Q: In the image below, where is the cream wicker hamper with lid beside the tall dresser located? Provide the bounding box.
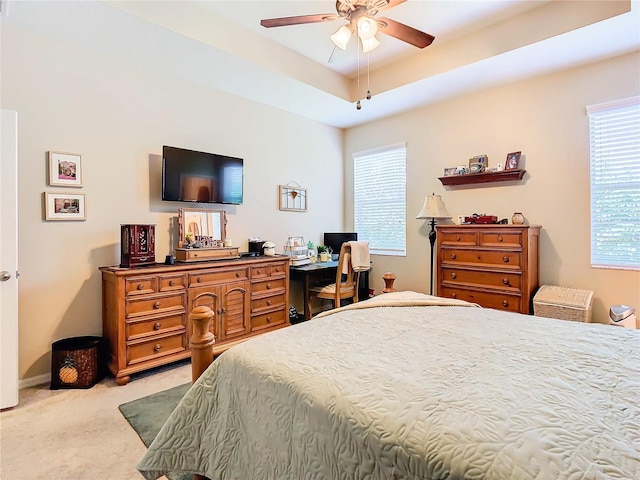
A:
[533,285,593,322]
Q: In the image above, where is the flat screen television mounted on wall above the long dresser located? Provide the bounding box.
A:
[162,145,243,205]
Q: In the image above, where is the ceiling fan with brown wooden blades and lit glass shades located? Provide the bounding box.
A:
[260,0,435,53]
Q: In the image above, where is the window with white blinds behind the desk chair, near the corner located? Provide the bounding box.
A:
[353,143,407,256]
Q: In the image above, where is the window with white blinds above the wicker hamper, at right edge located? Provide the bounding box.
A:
[587,96,640,270]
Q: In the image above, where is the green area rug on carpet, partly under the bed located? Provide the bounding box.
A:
[118,383,192,480]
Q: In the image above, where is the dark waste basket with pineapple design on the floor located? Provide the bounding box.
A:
[51,337,103,390]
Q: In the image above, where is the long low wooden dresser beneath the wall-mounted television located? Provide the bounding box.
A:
[100,256,289,385]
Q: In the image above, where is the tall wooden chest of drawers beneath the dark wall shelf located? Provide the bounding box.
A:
[436,224,541,313]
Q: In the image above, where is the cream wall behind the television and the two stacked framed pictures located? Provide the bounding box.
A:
[1,2,343,380]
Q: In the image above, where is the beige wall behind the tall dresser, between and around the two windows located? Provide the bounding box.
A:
[345,52,640,322]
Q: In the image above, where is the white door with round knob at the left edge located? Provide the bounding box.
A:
[0,110,18,408]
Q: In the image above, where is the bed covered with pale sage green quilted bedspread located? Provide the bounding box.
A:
[138,292,640,480]
